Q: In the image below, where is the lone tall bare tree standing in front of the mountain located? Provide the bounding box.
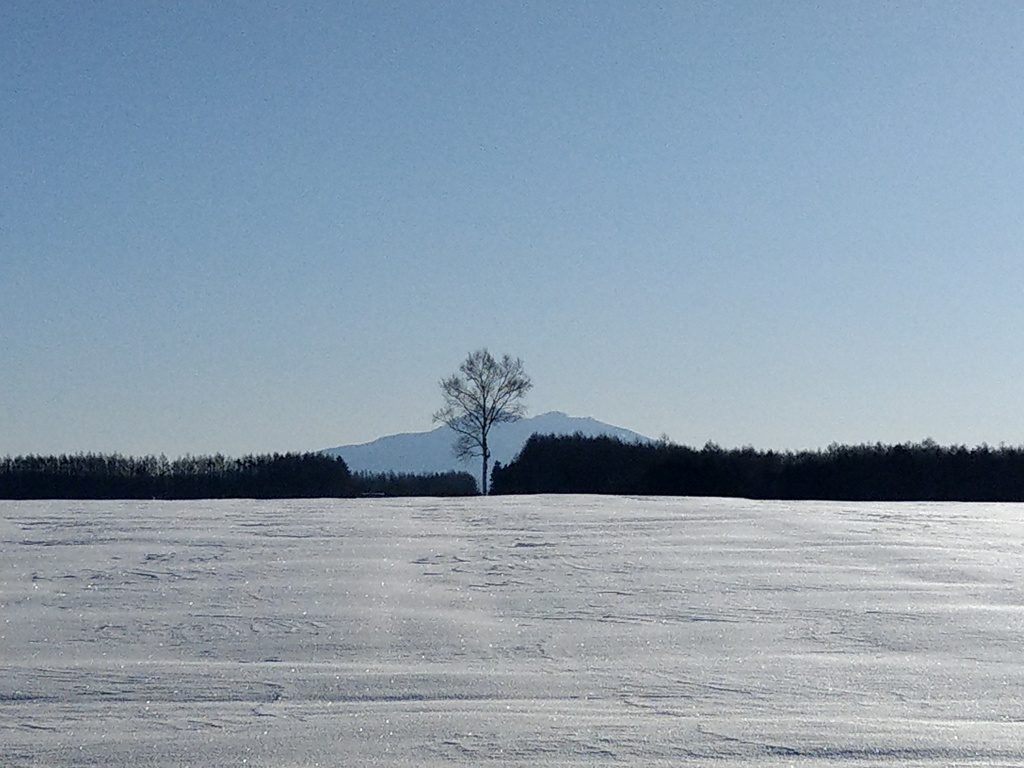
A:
[434,349,534,496]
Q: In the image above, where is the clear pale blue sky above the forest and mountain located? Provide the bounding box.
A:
[0,0,1024,456]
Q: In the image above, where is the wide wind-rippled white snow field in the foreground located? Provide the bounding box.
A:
[0,497,1024,768]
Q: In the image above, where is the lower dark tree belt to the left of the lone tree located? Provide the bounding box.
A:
[0,453,477,499]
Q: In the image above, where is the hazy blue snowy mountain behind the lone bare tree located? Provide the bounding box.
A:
[321,411,650,477]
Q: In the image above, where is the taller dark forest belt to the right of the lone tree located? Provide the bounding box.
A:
[492,434,1024,502]
